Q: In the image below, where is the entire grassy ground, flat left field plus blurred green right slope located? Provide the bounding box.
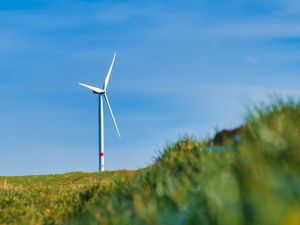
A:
[0,101,300,225]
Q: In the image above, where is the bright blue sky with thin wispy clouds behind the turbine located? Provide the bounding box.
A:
[0,0,300,175]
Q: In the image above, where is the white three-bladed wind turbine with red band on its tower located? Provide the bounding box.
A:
[79,53,121,171]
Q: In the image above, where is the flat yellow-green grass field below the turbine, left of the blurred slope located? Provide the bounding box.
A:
[0,171,133,225]
